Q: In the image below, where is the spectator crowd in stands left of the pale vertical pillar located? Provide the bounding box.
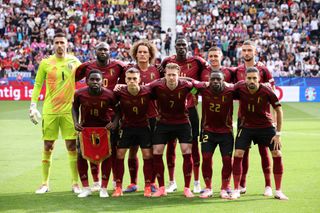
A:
[0,0,162,77]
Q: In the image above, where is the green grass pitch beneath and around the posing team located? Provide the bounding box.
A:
[0,102,320,213]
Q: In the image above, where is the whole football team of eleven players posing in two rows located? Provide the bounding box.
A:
[30,29,288,200]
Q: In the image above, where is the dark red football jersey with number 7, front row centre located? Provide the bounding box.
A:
[150,79,193,124]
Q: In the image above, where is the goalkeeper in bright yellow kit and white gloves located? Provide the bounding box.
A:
[30,30,81,194]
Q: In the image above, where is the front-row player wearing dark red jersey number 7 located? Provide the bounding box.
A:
[150,63,194,197]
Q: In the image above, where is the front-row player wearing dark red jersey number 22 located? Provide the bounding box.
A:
[194,71,234,199]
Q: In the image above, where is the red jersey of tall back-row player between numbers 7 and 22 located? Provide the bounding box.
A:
[160,55,210,108]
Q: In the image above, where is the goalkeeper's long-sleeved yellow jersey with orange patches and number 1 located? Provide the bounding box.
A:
[31,55,81,114]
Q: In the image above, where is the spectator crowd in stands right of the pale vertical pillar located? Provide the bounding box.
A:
[176,0,320,77]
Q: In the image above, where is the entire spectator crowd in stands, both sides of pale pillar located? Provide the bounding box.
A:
[0,0,320,80]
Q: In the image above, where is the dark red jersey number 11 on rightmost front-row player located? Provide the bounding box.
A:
[234,81,281,128]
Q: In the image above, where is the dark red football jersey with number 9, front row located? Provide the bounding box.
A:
[115,86,151,128]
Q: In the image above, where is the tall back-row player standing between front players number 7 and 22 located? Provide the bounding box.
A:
[161,38,210,193]
